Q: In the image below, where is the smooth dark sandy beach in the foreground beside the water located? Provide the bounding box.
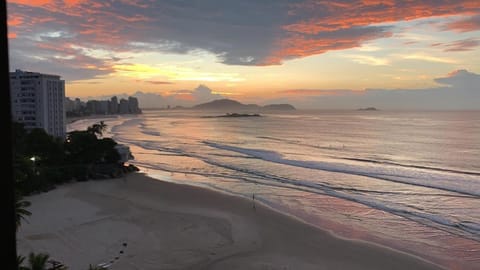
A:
[17,173,439,270]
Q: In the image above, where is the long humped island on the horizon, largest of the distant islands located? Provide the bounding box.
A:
[192,99,295,110]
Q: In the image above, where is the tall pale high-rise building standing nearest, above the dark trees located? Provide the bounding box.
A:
[10,69,66,137]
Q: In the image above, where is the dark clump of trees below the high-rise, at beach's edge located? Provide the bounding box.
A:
[13,121,127,195]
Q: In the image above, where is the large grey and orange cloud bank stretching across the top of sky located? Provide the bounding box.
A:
[8,0,480,80]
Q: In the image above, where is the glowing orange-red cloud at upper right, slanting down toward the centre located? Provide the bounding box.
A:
[262,0,480,65]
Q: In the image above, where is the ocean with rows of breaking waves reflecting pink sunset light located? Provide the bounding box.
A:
[68,110,480,269]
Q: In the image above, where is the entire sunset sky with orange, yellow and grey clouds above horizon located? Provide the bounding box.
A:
[7,0,480,109]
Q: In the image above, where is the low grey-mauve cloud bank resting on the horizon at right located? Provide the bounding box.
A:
[269,70,480,110]
